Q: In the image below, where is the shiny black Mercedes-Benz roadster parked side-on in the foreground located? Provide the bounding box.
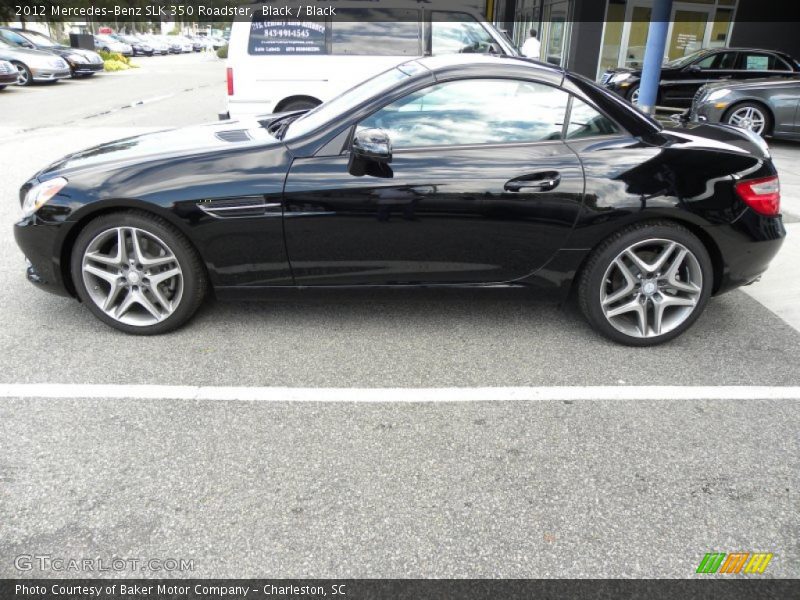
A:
[15,55,785,345]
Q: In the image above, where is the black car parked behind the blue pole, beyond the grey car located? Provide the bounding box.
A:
[600,48,800,108]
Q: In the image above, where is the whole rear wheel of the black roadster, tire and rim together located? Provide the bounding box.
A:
[578,221,713,346]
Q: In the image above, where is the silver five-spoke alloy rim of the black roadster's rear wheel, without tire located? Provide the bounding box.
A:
[600,239,703,338]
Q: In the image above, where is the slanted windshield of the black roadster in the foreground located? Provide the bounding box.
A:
[284,63,424,140]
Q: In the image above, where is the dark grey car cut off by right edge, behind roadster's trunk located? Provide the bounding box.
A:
[688,79,800,139]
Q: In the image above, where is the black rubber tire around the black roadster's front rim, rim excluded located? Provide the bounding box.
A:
[70,211,208,335]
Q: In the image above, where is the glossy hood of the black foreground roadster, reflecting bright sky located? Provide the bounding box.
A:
[36,120,283,181]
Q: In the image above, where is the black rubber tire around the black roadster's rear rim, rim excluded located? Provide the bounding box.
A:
[578,221,714,346]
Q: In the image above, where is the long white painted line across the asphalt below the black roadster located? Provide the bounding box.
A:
[0,383,800,403]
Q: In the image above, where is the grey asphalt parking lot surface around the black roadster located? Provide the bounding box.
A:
[0,55,800,577]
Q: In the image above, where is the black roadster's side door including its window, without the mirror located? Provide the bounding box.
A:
[284,79,584,285]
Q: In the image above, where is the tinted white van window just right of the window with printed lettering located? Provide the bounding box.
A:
[331,8,422,56]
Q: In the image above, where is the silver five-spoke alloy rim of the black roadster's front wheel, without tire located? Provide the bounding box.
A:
[81,227,183,327]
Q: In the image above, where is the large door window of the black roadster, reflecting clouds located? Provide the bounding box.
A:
[359,79,568,148]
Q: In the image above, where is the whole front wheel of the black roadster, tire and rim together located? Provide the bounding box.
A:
[71,212,207,335]
